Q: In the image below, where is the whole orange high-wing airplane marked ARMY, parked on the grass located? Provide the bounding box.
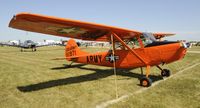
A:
[9,13,187,87]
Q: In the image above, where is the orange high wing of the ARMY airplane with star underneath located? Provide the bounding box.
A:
[9,13,174,41]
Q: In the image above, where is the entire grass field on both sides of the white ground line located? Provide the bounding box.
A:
[0,46,200,108]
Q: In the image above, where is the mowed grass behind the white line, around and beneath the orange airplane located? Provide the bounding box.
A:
[0,46,197,108]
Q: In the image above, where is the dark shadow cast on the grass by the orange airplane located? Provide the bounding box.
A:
[17,64,163,92]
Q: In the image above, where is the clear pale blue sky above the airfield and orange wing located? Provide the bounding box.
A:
[0,0,200,41]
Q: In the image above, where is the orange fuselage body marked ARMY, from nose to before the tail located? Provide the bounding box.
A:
[66,42,186,68]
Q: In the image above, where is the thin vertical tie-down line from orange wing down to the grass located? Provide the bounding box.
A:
[111,34,118,98]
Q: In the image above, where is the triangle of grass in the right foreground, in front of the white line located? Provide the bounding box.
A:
[110,66,200,108]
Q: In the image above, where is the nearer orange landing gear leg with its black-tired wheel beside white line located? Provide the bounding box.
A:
[140,65,152,87]
